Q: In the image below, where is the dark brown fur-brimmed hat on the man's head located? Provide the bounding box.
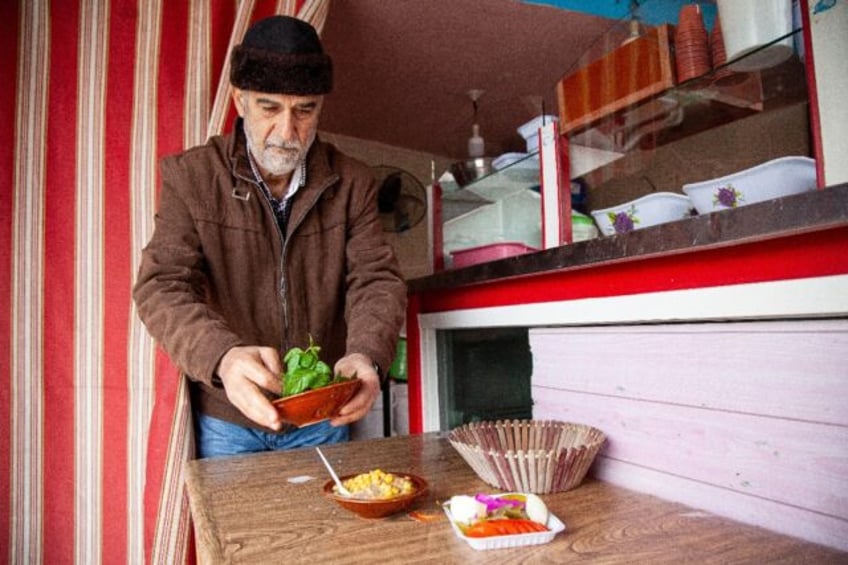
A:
[230,16,333,96]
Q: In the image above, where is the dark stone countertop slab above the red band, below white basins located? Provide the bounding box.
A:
[408,184,848,294]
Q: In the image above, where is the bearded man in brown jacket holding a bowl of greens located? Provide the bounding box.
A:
[133,16,406,457]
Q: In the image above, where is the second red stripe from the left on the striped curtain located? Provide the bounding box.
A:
[42,2,80,563]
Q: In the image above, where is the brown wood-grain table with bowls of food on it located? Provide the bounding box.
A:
[186,433,848,565]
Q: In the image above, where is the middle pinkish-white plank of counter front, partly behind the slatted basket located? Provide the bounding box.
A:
[532,386,848,520]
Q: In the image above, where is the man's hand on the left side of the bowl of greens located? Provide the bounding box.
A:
[218,346,282,430]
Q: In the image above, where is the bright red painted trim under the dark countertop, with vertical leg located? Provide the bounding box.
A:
[407,226,848,433]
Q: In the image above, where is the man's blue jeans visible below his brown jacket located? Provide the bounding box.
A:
[194,413,350,459]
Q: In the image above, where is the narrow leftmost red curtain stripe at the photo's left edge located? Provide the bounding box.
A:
[0,2,21,559]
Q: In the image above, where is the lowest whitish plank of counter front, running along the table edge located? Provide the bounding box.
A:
[588,456,848,551]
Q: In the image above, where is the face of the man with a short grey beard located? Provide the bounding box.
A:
[233,88,324,177]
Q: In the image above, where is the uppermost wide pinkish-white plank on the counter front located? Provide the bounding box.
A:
[530,320,848,426]
